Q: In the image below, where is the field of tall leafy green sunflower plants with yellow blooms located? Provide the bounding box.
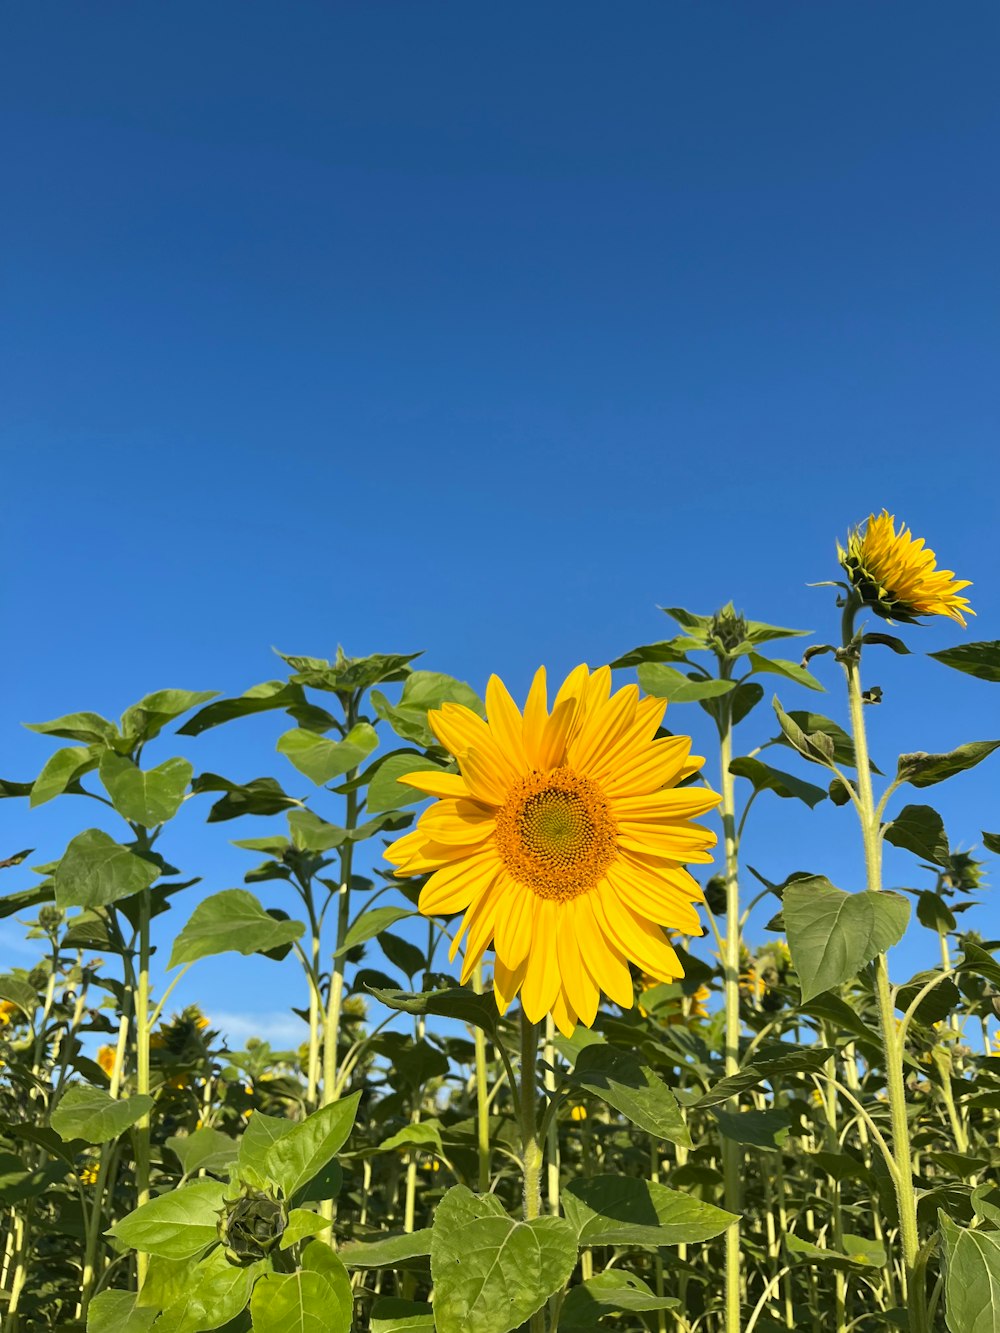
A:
[0,513,1000,1333]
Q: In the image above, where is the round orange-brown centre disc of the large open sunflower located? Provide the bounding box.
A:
[496,768,617,902]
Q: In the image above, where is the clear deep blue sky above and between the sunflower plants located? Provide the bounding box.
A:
[0,0,1000,1050]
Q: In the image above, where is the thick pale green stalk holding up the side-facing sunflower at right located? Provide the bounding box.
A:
[841,605,927,1333]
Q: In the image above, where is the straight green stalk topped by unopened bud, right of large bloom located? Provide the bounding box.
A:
[719,687,743,1333]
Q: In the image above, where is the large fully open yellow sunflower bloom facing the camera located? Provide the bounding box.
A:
[387,667,719,1036]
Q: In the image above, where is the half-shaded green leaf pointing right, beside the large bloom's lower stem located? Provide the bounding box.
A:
[563,1176,737,1246]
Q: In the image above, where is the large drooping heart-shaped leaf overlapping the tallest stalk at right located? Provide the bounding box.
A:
[783,876,909,1001]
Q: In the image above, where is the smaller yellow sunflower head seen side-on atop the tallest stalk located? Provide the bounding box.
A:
[837,509,976,625]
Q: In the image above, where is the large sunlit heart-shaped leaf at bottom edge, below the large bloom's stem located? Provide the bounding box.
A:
[431,1185,577,1333]
